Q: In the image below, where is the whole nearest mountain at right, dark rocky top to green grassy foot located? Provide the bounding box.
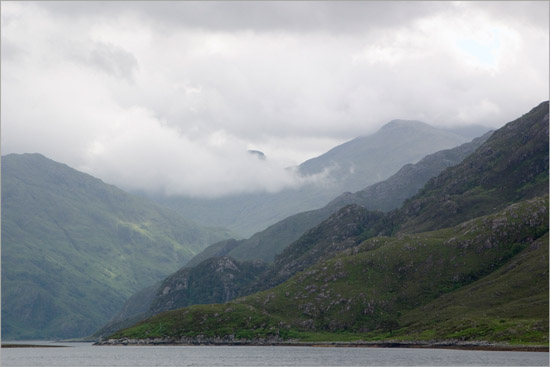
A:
[102,102,548,343]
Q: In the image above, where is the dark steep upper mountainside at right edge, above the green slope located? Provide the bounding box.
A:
[386,101,548,232]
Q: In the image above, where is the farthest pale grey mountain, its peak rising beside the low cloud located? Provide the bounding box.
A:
[154,120,470,237]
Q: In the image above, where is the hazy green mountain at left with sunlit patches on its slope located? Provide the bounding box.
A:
[2,154,230,339]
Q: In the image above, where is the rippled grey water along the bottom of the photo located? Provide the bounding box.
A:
[2,343,549,367]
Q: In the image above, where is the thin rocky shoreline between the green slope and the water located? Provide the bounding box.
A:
[94,335,549,352]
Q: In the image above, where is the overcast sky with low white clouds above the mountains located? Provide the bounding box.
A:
[1,1,550,197]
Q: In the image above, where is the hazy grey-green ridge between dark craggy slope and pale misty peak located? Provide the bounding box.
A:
[187,133,491,267]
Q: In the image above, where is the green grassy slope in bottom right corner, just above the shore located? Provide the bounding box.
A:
[395,233,548,343]
